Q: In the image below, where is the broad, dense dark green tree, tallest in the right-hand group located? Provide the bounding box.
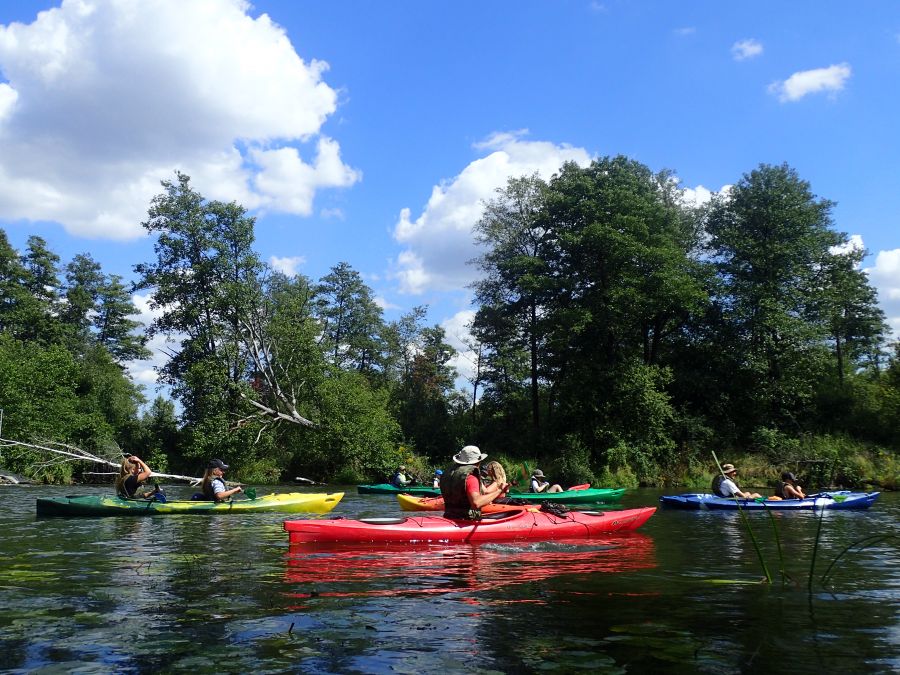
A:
[545,157,708,476]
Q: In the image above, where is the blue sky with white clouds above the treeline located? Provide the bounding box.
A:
[0,0,900,384]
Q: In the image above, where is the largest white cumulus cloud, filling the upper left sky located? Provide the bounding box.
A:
[0,0,360,240]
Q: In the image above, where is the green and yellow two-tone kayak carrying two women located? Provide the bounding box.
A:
[37,492,344,516]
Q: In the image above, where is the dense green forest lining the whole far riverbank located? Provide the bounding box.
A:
[0,164,900,487]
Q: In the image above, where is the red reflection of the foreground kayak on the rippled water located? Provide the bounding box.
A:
[285,533,657,599]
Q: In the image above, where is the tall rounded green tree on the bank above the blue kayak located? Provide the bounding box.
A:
[706,165,841,438]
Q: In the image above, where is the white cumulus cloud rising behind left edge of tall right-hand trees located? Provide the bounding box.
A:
[394,131,591,294]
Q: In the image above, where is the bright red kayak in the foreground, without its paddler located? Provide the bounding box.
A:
[284,506,656,544]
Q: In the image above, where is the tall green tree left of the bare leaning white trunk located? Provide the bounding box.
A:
[135,173,263,462]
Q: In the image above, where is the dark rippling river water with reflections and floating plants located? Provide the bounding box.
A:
[0,486,900,674]
